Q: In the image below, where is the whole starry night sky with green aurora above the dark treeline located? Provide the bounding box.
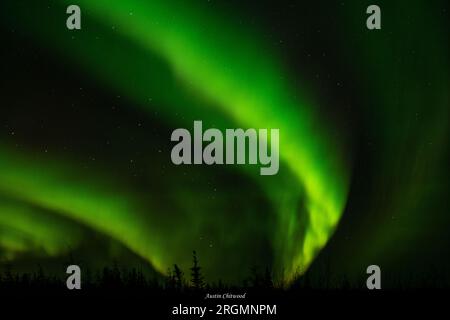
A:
[0,0,449,288]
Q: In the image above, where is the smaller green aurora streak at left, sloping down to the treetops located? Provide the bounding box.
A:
[0,146,165,270]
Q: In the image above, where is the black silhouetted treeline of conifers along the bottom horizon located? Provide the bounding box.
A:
[0,251,442,293]
